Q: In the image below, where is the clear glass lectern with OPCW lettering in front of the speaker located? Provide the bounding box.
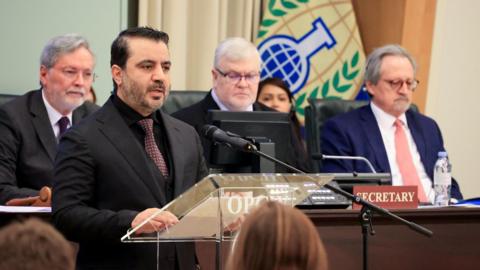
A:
[121,174,334,267]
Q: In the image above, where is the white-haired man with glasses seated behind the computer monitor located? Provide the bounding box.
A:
[172,37,310,170]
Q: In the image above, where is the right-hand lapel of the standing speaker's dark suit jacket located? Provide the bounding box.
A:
[160,112,185,197]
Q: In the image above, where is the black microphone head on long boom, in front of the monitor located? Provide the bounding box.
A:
[200,125,257,153]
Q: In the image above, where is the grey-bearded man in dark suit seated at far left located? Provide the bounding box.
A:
[0,34,98,204]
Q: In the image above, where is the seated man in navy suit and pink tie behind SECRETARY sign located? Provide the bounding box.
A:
[321,45,462,203]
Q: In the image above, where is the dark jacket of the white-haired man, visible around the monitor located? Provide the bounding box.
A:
[172,91,311,171]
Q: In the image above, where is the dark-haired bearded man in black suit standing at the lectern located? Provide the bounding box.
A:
[52,27,207,269]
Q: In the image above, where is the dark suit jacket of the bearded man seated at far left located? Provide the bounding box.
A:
[0,90,98,204]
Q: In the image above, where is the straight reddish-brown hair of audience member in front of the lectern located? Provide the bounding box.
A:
[227,201,328,270]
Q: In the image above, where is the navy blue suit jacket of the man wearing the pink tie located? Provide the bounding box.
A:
[321,105,462,198]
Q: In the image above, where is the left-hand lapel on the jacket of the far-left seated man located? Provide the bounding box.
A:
[30,90,57,162]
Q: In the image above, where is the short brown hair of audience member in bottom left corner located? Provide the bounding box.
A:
[0,218,75,270]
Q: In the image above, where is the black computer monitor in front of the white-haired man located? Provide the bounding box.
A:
[207,110,294,173]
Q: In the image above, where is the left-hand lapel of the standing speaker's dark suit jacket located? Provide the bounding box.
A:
[97,100,166,205]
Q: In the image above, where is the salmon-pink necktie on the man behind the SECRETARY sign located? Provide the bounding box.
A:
[394,119,429,202]
